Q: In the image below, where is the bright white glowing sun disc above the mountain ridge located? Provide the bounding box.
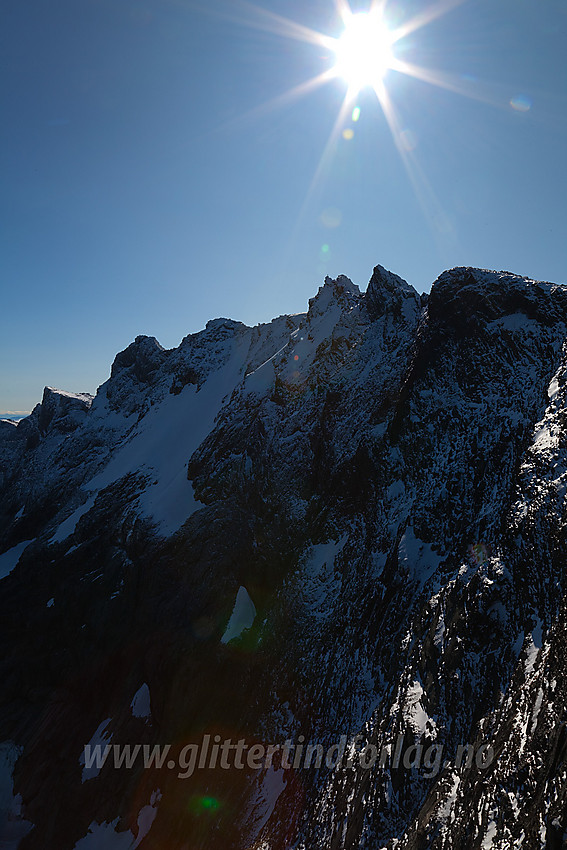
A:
[334,12,394,91]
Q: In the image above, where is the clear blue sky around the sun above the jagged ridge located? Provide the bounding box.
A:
[0,0,567,414]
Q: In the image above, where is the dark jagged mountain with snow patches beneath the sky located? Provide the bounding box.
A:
[0,266,567,850]
